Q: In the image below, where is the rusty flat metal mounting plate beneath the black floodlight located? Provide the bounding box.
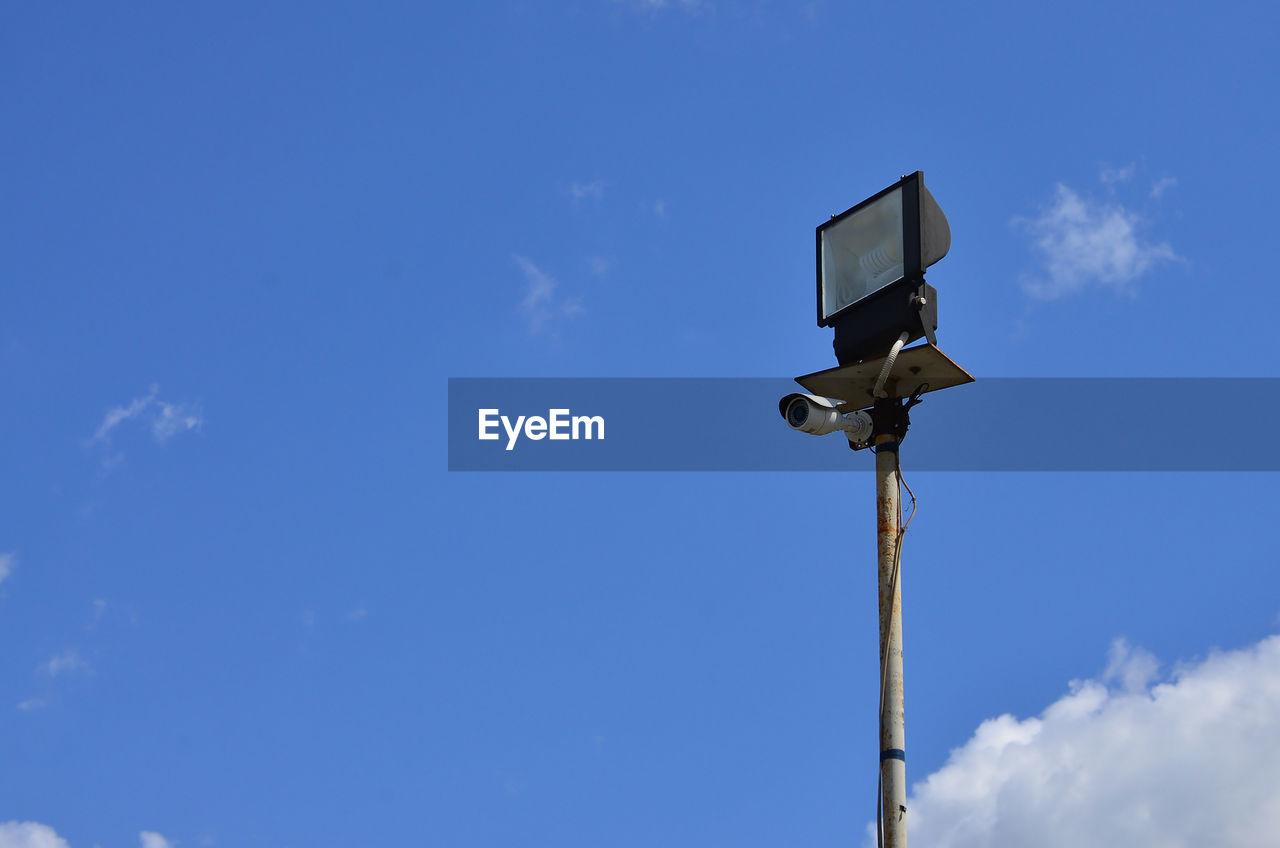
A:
[796,345,973,412]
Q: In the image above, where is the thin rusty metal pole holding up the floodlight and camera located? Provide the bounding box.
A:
[876,433,906,848]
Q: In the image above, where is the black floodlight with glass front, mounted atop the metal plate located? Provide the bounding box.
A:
[818,170,951,365]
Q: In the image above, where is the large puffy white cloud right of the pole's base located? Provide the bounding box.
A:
[890,635,1280,848]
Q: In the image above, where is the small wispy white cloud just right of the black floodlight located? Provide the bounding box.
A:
[1014,183,1178,300]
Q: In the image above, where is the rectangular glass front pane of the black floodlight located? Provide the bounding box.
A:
[822,188,905,318]
